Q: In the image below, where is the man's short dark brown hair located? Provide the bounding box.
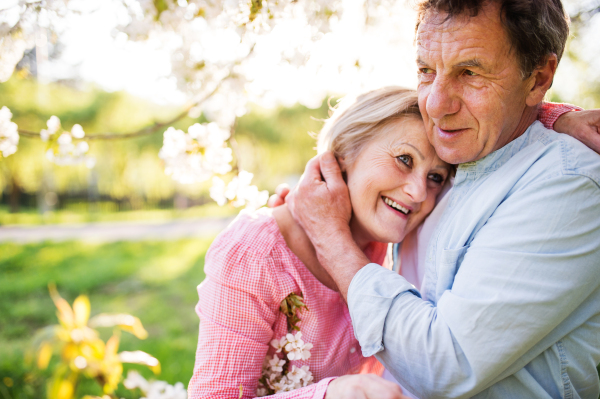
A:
[417,0,569,78]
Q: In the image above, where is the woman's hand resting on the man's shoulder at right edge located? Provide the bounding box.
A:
[554,109,600,154]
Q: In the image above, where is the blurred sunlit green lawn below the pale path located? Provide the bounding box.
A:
[0,238,212,399]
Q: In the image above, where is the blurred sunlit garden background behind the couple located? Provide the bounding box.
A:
[0,0,600,399]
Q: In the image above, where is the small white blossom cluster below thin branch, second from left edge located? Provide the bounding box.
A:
[40,116,96,168]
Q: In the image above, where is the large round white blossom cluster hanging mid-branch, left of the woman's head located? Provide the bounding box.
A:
[158,122,233,184]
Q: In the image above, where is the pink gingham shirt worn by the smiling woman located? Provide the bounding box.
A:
[188,103,581,399]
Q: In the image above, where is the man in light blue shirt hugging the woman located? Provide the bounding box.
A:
[290,0,600,399]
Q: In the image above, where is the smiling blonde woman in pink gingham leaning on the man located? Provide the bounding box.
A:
[188,87,580,399]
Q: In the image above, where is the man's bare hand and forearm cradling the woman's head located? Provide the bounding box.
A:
[287,152,369,298]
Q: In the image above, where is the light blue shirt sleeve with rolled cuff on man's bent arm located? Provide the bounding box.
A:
[348,175,600,398]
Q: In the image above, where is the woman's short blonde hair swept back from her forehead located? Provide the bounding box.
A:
[317,86,421,165]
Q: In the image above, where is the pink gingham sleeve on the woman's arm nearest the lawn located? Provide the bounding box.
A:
[188,228,331,399]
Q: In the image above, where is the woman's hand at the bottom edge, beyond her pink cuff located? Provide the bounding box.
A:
[325,374,407,399]
